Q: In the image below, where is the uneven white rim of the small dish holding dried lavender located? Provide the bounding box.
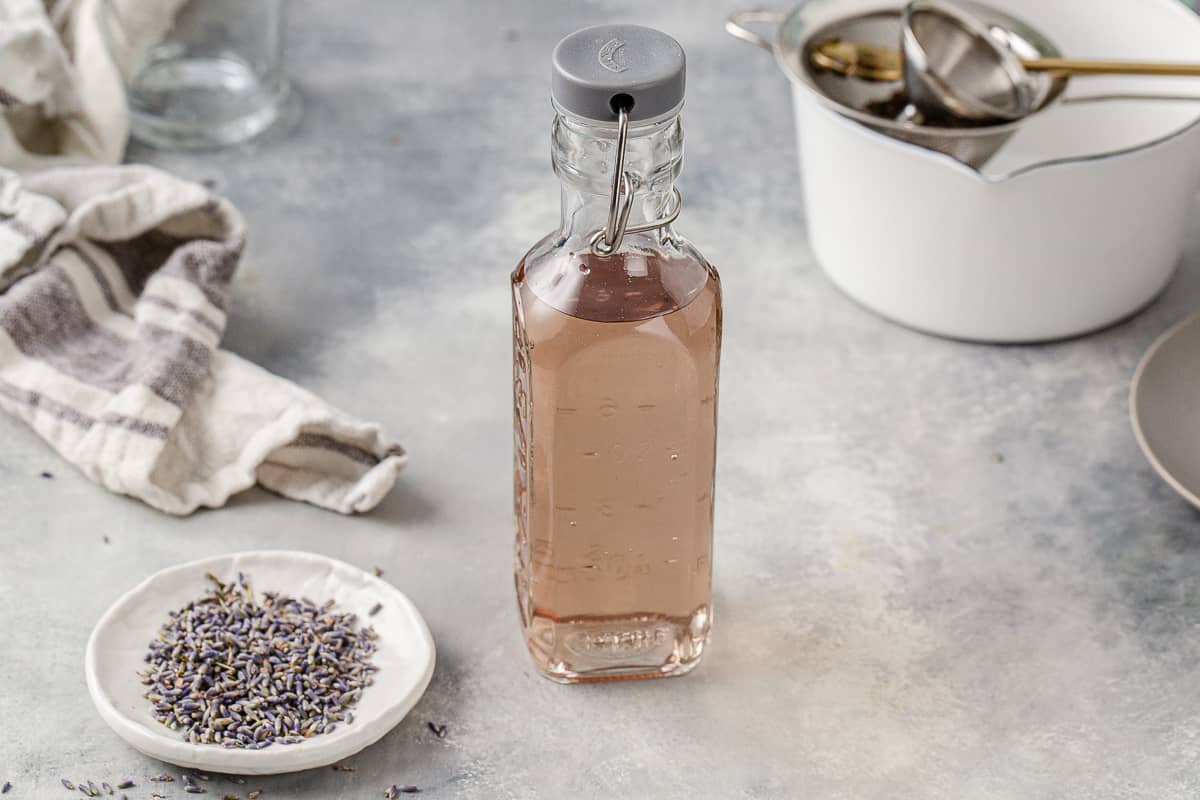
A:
[84,551,434,775]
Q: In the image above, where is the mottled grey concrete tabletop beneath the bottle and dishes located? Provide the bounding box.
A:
[0,0,1200,800]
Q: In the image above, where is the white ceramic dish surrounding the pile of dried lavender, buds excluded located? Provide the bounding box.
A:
[85,551,434,775]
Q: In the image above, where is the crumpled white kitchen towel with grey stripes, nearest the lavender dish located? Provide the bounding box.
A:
[0,166,406,515]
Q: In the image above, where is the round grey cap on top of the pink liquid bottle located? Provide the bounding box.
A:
[551,25,685,122]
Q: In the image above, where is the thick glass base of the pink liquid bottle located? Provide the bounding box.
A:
[526,606,712,684]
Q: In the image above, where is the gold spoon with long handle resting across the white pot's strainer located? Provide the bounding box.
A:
[809,38,1200,80]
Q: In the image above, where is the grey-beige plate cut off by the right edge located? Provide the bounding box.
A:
[1129,313,1200,509]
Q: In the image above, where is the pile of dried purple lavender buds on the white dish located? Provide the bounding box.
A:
[142,573,378,750]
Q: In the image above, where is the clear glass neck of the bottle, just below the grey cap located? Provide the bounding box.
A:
[551,114,683,240]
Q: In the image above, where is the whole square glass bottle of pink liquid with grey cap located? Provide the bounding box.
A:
[512,25,721,682]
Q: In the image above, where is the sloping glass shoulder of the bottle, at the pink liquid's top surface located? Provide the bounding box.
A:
[512,233,720,321]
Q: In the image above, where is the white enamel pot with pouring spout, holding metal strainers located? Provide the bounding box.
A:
[729,0,1200,342]
